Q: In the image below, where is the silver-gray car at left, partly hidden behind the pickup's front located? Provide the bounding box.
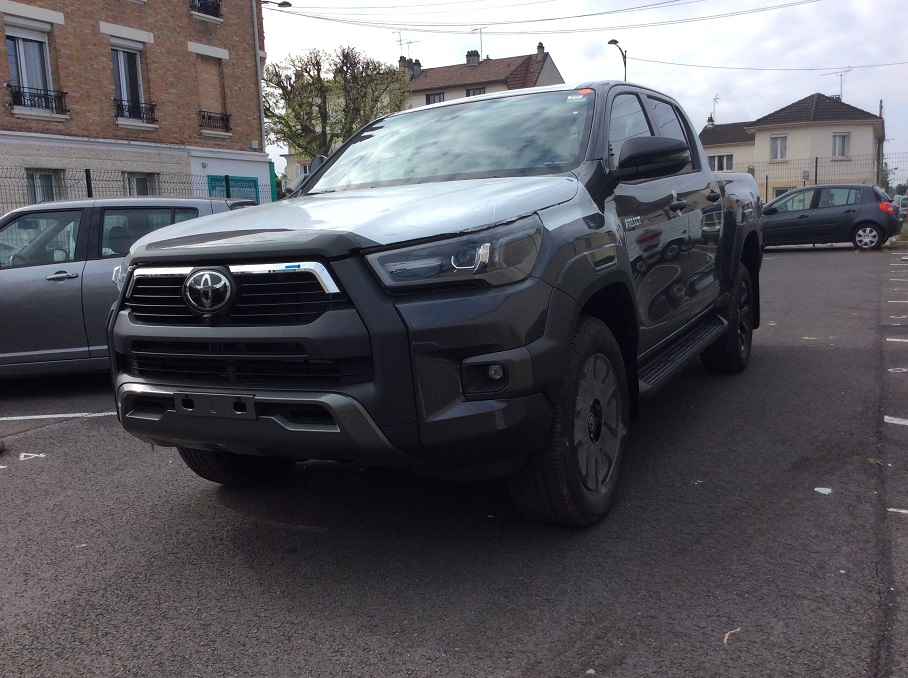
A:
[0,197,255,377]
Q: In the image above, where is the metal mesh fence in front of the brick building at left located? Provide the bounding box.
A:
[0,167,272,214]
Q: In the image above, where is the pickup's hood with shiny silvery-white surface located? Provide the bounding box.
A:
[131,175,579,260]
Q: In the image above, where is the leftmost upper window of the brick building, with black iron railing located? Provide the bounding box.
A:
[6,26,67,114]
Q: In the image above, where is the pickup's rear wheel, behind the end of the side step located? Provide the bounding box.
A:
[700,264,754,374]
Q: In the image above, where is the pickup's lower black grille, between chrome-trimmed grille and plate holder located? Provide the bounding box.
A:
[118,341,375,389]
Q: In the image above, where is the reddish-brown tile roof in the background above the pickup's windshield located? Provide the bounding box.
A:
[407,52,549,92]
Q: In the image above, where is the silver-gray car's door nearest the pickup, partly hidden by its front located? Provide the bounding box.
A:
[82,206,199,358]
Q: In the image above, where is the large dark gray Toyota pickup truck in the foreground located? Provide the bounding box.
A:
[109,82,762,525]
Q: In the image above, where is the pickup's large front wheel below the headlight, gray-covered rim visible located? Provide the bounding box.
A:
[508,316,629,525]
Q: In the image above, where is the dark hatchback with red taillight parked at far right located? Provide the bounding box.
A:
[763,184,899,250]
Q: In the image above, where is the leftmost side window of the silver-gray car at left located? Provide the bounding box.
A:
[0,210,82,268]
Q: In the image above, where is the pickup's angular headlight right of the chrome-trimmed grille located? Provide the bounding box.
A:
[366,215,543,287]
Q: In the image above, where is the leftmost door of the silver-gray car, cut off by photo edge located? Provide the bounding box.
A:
[0,209,88,365]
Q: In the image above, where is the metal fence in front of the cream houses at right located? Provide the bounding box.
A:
[731,153,908,200]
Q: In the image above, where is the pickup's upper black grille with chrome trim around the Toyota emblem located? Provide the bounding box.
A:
[125,264,351,326]
